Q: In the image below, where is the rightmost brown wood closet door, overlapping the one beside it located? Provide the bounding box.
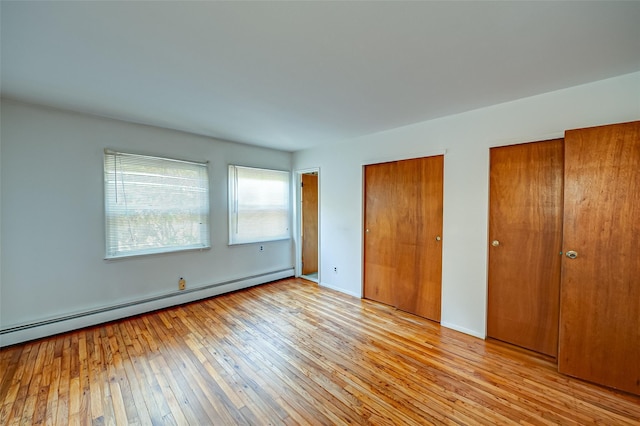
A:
[558,121,640,394]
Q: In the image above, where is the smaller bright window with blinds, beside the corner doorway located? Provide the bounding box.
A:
[229,166,290,244]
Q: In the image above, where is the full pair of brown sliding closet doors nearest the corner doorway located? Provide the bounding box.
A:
[364,156,444,321]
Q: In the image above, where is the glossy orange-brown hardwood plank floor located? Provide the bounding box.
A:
[0,279,640,425]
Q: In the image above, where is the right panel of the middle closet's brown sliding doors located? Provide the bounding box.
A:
[395,155,444,322]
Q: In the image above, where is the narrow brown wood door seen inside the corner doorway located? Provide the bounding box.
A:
[301,173,318,275]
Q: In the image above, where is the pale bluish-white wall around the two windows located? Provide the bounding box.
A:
[0,100,294,344]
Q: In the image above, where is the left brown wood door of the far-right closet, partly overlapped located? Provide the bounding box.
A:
[487,139,563,357]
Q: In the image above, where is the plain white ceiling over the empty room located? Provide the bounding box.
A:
[0,1,640,151]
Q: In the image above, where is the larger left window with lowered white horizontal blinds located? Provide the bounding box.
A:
[104,150,210,259]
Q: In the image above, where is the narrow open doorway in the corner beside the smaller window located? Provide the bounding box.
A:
[299,169,320,282]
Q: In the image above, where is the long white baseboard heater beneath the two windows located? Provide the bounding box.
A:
[0,268,294,347]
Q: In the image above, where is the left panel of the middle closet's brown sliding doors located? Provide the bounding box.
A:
[364,163,396,306]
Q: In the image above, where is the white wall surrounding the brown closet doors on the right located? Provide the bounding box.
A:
[293,73,640,338]
